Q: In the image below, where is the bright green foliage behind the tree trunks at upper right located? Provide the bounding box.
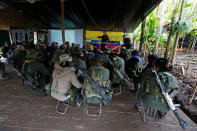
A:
[133,0,197,49]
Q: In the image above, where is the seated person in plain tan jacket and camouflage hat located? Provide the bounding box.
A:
[51,54,82,106]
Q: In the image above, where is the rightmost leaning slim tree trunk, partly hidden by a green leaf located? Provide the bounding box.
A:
[172,0,185,64]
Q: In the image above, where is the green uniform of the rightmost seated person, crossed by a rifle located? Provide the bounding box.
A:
[140,72,178,112]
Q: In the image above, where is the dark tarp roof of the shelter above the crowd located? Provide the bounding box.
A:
[0,0,161,32]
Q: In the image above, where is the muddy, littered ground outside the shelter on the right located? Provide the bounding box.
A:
[173,51,197,123]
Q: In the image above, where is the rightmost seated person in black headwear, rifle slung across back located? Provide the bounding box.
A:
[138,58,178,114]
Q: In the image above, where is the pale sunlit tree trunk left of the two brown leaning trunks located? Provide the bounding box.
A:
[153,1,167,54]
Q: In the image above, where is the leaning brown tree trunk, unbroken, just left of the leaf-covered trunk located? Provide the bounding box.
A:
[164,1,178,58]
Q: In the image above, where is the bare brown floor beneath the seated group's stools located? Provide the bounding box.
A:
[0,65,197,131]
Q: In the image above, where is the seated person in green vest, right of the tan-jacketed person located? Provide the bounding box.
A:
[83,55,112,104]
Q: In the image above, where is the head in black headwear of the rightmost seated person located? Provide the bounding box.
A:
[155,58,172,72]
